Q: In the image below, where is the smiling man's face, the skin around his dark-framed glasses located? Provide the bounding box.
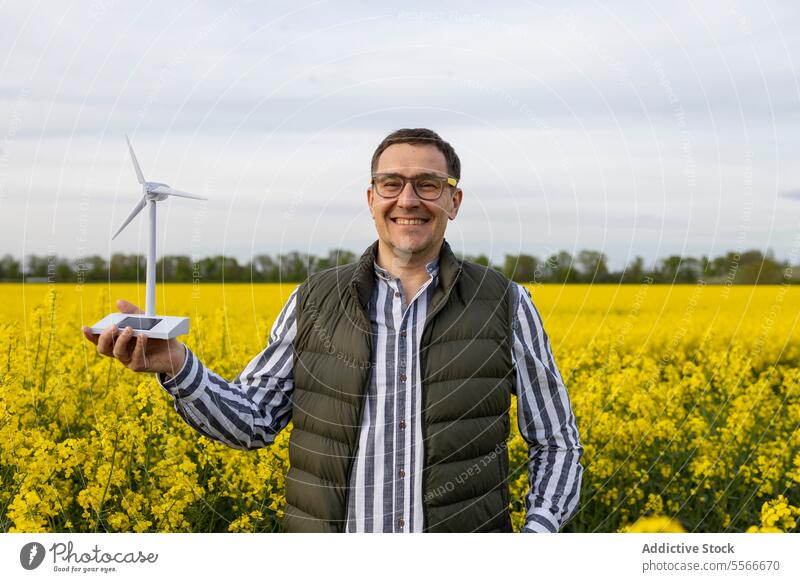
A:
[367,143,462,260]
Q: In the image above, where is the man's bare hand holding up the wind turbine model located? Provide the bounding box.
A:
[82,299,186,376]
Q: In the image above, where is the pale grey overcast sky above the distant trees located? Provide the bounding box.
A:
[0,0,800,268]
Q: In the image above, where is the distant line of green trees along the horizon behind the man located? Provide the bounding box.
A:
[0,249,800,284]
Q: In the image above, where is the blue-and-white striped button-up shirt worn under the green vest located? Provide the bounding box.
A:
[156,259,583,532]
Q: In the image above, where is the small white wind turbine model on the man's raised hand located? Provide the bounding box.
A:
[91,135,208,339]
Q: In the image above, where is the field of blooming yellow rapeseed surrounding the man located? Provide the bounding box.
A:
[0,284,800,532]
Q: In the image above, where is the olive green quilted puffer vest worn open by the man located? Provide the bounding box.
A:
[283,241,515,532]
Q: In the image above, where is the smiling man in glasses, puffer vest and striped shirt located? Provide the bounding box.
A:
[84,129,583,532]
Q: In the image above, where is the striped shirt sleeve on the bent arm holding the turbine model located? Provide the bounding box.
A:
[156,288,297,450]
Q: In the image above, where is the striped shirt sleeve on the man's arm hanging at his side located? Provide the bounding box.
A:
[512,283,583,533]
